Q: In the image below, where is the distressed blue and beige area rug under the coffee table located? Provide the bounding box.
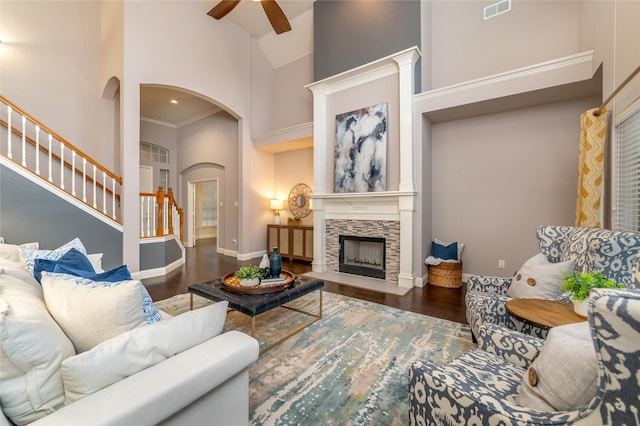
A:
[156,292,475,425]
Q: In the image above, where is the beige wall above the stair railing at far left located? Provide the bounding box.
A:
[0,0,117,170]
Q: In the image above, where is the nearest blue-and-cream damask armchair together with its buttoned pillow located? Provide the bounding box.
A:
[409,289,640,425]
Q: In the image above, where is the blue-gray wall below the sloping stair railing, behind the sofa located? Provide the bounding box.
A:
[0,165,122,270]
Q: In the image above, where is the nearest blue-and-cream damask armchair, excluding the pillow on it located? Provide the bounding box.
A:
[409,289,640,425]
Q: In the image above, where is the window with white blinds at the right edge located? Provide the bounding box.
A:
[613,105,640,231]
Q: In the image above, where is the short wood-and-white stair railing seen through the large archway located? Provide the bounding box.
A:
[140,186,184,241]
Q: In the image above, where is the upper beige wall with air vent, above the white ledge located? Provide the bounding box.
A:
[430,0,579,89]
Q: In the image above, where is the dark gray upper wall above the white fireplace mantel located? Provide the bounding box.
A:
[313,0,421,93]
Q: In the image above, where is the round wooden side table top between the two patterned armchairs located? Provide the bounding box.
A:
[506,299,587,329]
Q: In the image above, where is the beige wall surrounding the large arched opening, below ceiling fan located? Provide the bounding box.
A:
[122,1,272,266]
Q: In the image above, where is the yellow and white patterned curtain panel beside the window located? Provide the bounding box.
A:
[576,108,607,228]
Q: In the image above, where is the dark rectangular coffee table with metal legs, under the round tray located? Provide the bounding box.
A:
[187,276,324,354]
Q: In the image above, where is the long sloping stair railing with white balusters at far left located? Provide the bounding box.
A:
[0,95,122,223]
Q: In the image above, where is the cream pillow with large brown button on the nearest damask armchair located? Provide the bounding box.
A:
[518,321,598,411]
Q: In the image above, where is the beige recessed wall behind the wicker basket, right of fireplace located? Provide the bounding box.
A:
[431,98,598,276]
